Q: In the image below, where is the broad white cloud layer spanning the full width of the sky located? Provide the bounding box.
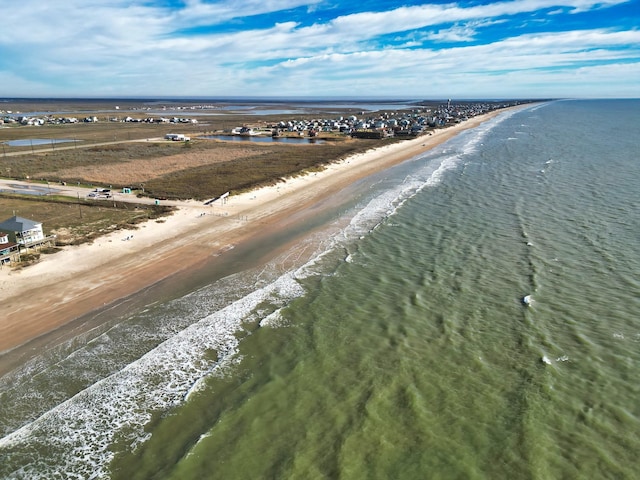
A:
[0,0,640,96]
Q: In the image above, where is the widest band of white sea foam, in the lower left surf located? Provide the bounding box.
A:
[0,274,303,479]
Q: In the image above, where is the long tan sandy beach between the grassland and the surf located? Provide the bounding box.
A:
[0,107,510,358]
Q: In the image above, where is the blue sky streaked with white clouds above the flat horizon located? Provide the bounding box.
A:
[0,0,640,99]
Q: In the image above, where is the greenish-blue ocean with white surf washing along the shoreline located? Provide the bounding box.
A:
[0,100,640,480]
